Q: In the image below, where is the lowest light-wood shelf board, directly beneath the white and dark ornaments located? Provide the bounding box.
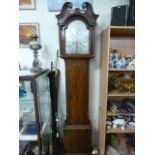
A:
[106,127,135,133]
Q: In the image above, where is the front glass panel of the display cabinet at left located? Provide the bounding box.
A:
[19,81,37,141]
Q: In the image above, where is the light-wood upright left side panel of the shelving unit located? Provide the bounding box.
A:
[99,28,110,155]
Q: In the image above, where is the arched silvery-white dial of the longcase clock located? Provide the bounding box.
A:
[65,20,89,54]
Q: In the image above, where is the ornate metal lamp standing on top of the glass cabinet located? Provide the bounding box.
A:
[29,34,43,72]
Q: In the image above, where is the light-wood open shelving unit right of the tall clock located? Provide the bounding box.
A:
[99,26,135,155]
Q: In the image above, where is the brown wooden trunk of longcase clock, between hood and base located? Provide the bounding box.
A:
[66,60,89,125]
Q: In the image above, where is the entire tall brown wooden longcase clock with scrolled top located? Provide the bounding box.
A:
[56,2,98,154]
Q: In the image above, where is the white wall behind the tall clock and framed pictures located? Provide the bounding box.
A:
[19,0,129,145]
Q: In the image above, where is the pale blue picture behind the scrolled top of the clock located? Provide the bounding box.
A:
[48,0,93,11]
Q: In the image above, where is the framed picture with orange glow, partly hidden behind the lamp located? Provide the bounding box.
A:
[19,23,40,47]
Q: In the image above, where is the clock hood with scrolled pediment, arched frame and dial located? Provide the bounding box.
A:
[56,2,98,59]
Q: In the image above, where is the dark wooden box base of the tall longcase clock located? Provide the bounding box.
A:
[64,125,92,155]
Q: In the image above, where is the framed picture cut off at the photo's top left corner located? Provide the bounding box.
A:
[19,0,36,10]
